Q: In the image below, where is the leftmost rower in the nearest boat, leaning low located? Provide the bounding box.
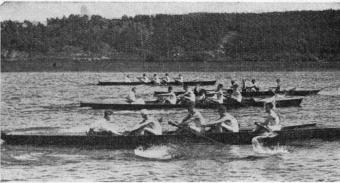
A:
[88,111,121,135]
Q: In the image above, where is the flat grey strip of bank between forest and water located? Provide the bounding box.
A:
[1,60,340,72]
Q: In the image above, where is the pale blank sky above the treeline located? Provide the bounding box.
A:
[0,1,340,23]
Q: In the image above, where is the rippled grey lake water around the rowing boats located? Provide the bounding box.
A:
[1,72,340,181]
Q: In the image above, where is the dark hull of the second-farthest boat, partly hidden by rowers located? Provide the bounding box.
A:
[154,90,320,97]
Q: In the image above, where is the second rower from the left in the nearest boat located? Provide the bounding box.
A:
[130,109,162,135]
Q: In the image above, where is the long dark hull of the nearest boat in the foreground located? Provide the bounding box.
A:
[1,127,340,149]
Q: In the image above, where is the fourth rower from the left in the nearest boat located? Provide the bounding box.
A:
[205,106,239,133]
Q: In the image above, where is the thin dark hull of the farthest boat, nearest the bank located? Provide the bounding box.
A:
[97,80,216,86]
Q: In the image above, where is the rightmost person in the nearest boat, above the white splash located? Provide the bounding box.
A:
[254,103,281,132]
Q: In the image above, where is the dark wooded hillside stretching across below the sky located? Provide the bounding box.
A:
[1,10,340,62]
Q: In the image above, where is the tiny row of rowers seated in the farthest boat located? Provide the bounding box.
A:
[125,73,184,84]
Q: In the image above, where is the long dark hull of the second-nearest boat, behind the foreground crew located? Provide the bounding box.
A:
[80,98,303,110]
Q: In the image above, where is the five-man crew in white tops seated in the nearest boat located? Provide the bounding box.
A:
[88,103,281,137]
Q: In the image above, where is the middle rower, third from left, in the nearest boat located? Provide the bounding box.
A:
[180,105,206,133]
